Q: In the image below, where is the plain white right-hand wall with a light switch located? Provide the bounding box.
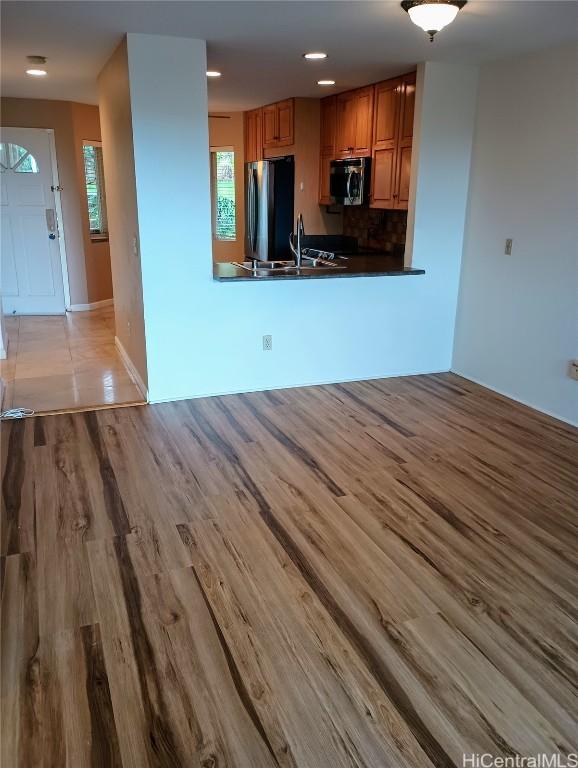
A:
[453,44,578,424]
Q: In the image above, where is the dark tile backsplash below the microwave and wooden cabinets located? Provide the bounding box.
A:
[343,206,407,251]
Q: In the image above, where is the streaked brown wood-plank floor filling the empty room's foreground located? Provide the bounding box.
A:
[2,374,578,768]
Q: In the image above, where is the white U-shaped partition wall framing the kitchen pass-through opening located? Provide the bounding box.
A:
[128,34,477,401]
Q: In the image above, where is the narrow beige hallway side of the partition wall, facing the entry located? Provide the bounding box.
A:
[98,40,147,385]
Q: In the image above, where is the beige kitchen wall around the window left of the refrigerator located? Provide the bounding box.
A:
[209,112,245,261]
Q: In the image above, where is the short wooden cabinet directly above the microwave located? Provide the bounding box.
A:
[335,85,374,158]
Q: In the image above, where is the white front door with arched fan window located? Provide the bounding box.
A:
[0,128,65,315]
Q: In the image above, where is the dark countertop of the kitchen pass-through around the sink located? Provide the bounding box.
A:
[213,252,425,282]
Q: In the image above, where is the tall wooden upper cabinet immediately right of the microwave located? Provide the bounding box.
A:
[370,72,416,209]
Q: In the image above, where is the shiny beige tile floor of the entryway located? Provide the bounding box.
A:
[0,307,143,413]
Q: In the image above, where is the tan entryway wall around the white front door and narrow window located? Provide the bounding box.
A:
[1,98,112,304]
